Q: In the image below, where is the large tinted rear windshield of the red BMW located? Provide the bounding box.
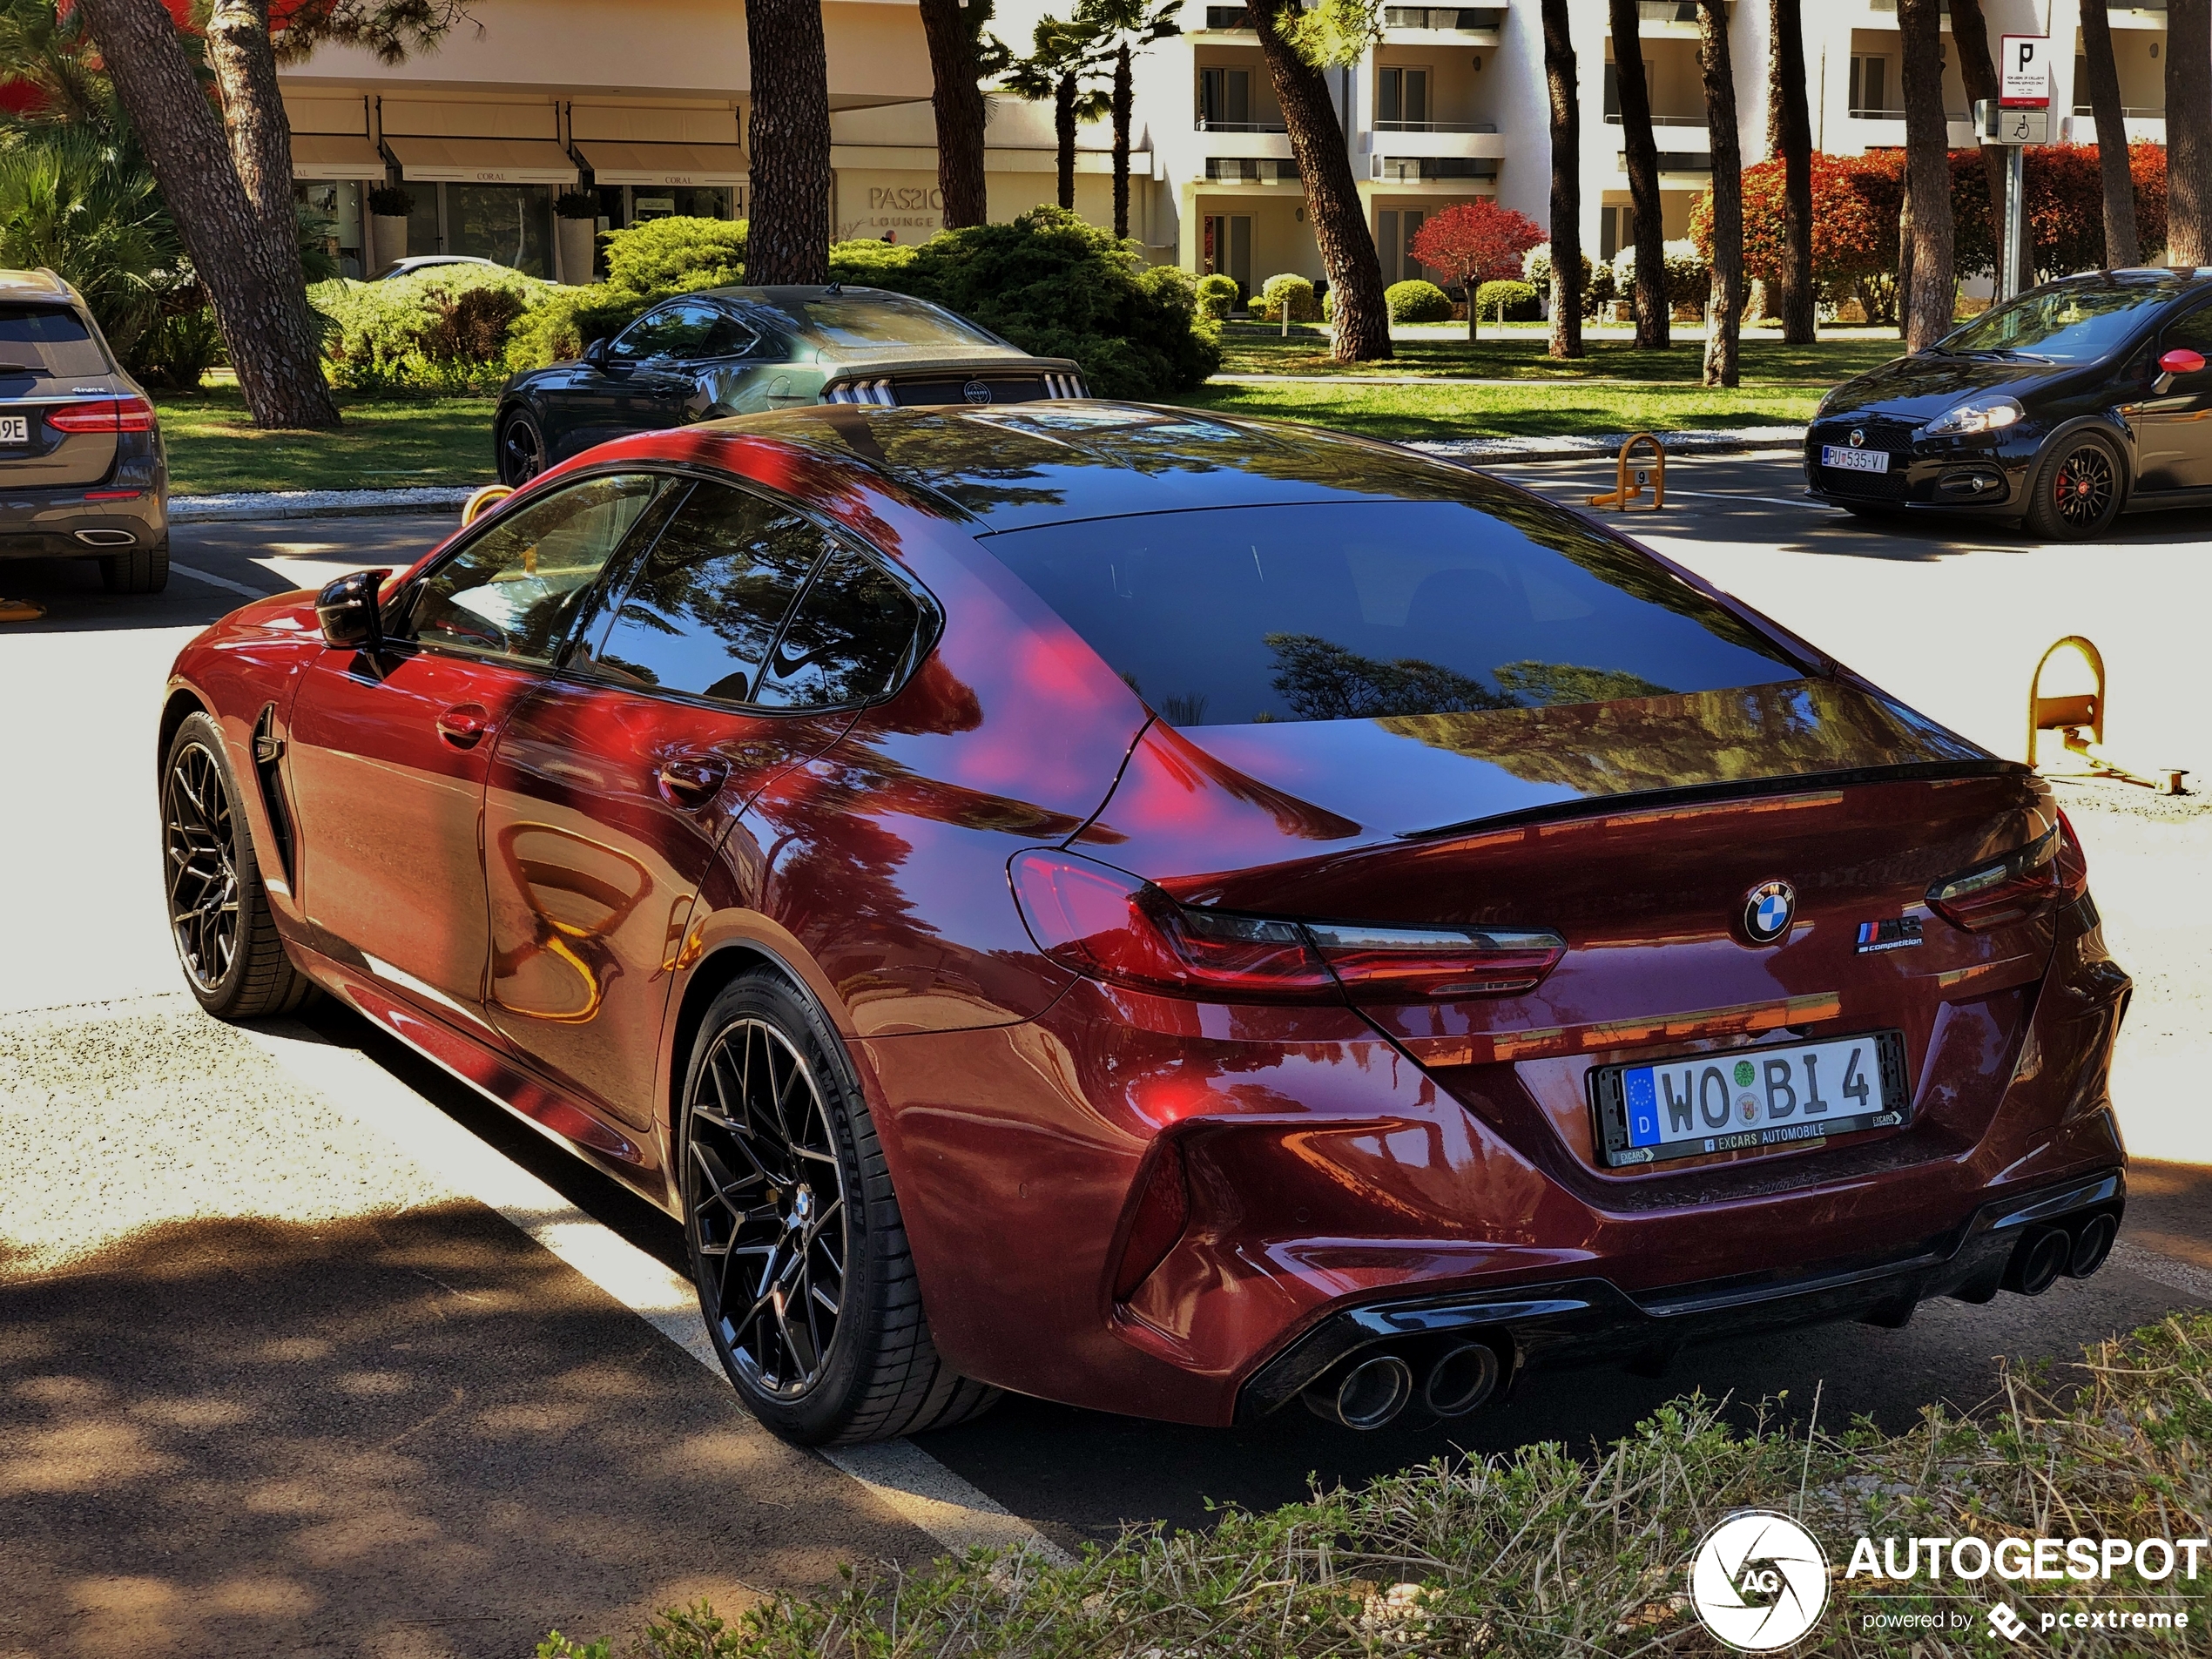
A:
[984,498,1803,725]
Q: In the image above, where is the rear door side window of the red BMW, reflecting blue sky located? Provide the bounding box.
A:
[577,484,825,704]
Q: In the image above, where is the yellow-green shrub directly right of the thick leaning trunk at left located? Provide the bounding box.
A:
[310,266,557,394]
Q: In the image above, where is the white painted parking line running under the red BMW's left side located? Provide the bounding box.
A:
[239,1020,1069,1561]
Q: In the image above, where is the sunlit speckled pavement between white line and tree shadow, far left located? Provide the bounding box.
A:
[0,995,454,1278]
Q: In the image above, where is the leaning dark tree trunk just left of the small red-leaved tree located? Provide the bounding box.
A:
[1252,0,1392,363]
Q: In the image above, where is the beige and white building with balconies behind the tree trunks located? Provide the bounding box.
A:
[283,0,2166,286]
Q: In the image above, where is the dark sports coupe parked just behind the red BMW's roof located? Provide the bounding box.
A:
[491,283,1089,484]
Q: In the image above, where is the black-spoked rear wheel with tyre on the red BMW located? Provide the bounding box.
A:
[677,969,998,1445]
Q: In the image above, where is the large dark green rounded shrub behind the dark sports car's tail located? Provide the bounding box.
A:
[830,208,1221,398]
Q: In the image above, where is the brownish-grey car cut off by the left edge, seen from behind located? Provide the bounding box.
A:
[0,270,168,593]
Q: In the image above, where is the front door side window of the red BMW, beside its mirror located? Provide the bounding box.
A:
[409,474,671,664]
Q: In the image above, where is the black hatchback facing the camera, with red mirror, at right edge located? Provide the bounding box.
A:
[1805,270,2212,540]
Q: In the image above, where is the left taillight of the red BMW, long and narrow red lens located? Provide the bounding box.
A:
[1011,852,1566,1004]
